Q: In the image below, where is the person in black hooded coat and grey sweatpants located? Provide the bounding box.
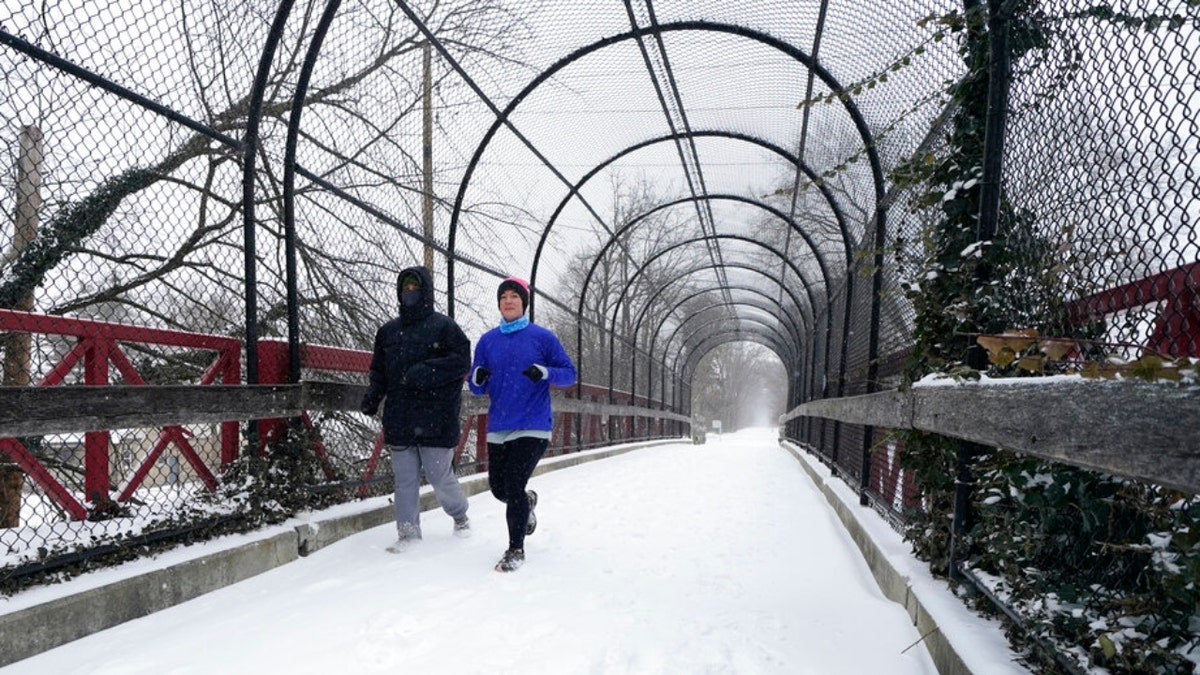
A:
[361,267,470,552]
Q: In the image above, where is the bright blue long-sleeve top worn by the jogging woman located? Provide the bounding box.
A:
[468,323,576,432]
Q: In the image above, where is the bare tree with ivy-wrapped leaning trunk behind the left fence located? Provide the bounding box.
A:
[0,0,535,355]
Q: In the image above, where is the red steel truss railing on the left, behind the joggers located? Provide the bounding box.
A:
[0,310,686,520]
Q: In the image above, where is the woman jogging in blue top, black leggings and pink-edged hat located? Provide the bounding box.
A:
[468,276,576,572]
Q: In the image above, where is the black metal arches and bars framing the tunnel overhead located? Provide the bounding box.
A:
[218,0,886,441]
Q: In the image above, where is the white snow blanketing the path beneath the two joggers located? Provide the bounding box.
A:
[0,429,1024,675]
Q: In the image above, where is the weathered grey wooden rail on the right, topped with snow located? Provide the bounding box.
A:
[780,378,1200,492]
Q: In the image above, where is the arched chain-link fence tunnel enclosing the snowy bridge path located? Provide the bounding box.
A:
[0,0,1200,667]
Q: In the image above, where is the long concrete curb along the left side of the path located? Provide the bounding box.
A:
[0,438,686,668]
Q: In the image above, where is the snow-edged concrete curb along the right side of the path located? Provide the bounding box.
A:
[780,443,972,675]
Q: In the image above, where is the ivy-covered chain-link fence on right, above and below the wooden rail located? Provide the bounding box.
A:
[791,2,1200,673]
